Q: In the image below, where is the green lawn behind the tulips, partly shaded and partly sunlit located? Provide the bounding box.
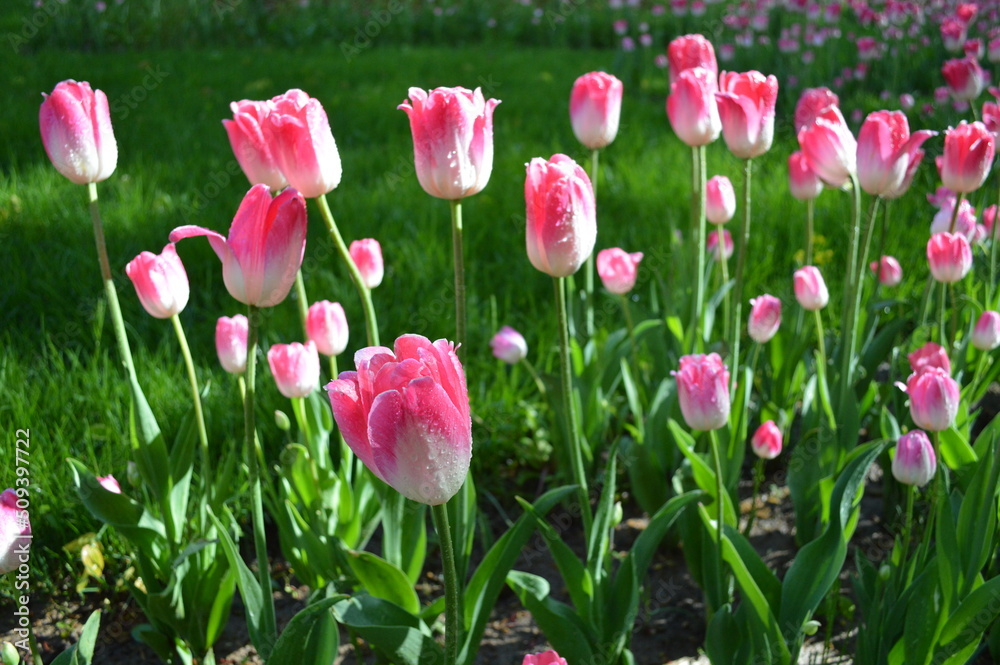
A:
[0,45,968,585]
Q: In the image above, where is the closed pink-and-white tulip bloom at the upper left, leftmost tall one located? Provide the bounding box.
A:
[38,79,118,185]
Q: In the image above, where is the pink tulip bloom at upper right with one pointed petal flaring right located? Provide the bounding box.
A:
[857,111,937,196]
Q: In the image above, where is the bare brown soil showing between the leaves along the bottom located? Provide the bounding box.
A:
[0,460,984,665]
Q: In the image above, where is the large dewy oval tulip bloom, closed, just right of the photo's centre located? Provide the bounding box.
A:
[524,154,597,277]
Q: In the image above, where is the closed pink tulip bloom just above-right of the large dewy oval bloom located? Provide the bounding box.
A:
[569,72,622,150]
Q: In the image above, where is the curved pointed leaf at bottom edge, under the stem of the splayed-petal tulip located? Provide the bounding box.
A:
[267,595,346,665]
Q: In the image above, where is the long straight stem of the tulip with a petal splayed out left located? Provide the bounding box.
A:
[243,305,277,644]
